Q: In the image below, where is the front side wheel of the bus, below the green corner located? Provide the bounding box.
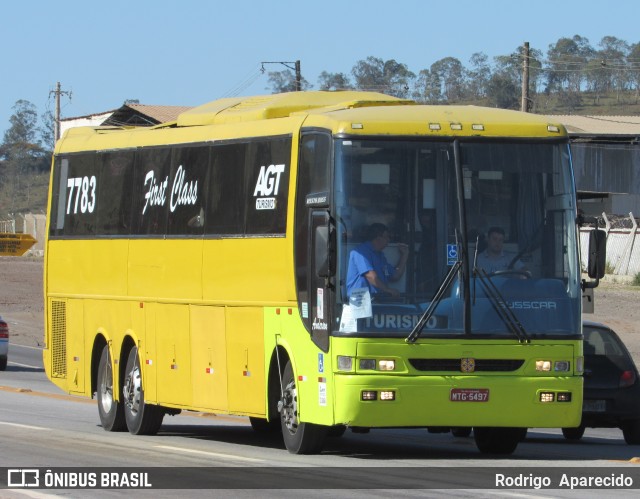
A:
[279,362,327,454]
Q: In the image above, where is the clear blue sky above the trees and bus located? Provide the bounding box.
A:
[0,0,640,141]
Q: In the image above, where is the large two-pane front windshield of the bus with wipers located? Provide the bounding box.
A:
[334,138,581,340]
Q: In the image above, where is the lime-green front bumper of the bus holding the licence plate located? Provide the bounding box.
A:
[334,374,582,428]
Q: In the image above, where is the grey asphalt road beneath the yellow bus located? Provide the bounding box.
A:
[0,346,640,498]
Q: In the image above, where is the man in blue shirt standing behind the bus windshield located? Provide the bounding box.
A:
[347,223,409,297]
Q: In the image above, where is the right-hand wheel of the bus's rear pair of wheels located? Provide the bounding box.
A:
[122,347,164,435]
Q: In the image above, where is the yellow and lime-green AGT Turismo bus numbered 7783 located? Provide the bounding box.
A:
[44,92,594,454]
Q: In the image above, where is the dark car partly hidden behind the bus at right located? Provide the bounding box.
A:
[562,321,640,445]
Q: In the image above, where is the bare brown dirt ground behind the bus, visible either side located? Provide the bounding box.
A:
[0,257,640,366]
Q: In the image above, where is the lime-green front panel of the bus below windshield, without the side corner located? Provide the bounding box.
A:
[332,338,582,428]
